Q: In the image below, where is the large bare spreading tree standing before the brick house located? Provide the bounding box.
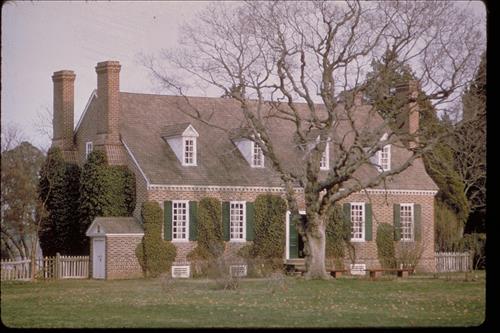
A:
[144,1,484,278]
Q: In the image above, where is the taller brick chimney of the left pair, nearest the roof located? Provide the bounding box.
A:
[95,61,121,144]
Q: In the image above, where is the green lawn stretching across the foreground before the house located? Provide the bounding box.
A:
[1,272,485,328]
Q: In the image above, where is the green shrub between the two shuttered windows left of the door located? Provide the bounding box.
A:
[187,198,224,260]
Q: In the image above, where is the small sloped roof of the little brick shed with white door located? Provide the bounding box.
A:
[86,217,144,236]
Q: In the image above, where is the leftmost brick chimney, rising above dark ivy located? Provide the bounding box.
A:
[52,70,76,151]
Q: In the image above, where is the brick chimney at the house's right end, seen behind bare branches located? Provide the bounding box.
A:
[396,80,420,147]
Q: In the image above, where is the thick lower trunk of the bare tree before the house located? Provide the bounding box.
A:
[304,222,331,280]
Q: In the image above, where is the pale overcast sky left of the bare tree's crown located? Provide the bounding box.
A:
[1,1,485,147]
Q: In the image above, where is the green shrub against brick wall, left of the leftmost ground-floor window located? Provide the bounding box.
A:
[135,201,177,277]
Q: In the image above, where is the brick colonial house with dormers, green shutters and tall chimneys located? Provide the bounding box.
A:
[52,61,438,278]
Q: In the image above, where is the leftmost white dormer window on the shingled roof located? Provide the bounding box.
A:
[161,123,199,166]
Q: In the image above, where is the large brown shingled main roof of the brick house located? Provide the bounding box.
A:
[120,92,438,190]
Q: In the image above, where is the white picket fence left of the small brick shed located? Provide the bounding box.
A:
[1,255,89,281]
